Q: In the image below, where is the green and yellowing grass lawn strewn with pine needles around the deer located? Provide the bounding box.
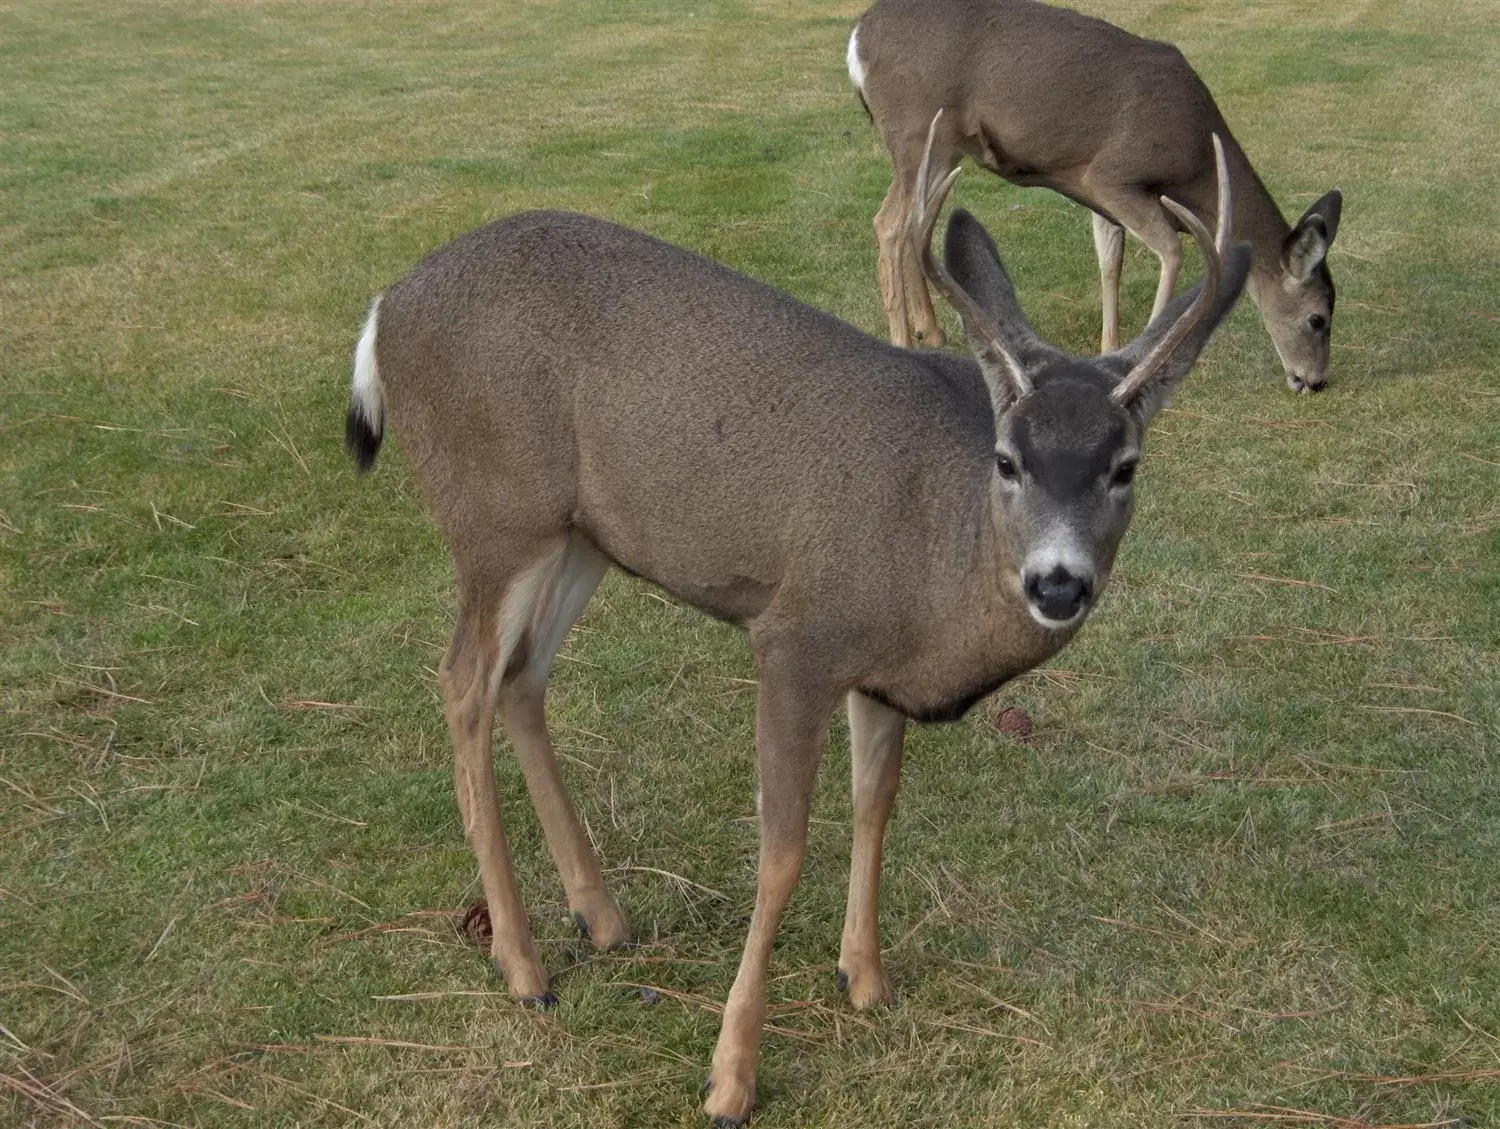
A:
[0,0,1500,1129]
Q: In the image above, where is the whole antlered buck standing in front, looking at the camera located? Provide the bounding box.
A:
[347,123,1250,1126]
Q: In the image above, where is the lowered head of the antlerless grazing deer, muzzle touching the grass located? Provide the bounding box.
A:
[1256,189,1343,391]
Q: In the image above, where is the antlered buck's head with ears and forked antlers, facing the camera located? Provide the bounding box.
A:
[911,111,1250,631]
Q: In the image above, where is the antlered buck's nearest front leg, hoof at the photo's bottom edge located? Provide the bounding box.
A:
[704,664,834,1128]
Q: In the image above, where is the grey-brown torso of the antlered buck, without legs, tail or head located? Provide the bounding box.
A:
[378,213,993,622]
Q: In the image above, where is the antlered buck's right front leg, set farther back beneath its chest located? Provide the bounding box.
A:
[839,691,906,1011]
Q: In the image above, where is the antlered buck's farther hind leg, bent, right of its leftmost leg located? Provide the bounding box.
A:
[500,532,630,949]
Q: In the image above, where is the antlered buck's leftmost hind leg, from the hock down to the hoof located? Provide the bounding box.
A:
[438,612,557,1008]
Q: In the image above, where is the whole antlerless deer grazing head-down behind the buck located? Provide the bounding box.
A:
[846,0,1343,391]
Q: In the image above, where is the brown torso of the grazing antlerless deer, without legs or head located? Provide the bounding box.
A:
[855,0,1229,193]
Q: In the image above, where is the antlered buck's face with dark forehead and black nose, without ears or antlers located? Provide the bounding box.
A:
[992,374,1142,631]
